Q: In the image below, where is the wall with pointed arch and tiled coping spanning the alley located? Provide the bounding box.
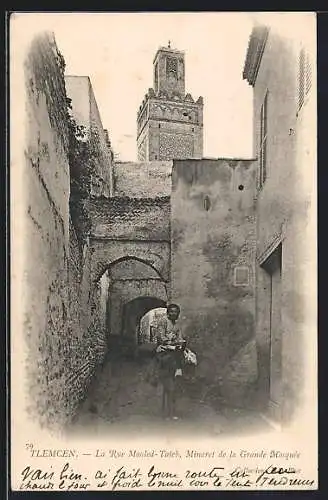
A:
[85,194,171,344]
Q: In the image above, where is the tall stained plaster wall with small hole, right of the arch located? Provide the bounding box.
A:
[171,160,256,402]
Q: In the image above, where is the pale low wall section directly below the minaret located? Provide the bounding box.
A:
[113,161,172,198]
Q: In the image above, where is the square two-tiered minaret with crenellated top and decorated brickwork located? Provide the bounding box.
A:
[137,42,203,161]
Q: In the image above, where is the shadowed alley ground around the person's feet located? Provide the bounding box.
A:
[72,352,271,436]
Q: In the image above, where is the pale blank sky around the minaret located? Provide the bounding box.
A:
[11,12,316,161]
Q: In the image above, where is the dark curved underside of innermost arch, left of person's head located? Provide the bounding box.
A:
[122,297,166,343]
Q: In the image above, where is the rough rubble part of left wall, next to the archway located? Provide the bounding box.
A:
[65,224,108,418]
